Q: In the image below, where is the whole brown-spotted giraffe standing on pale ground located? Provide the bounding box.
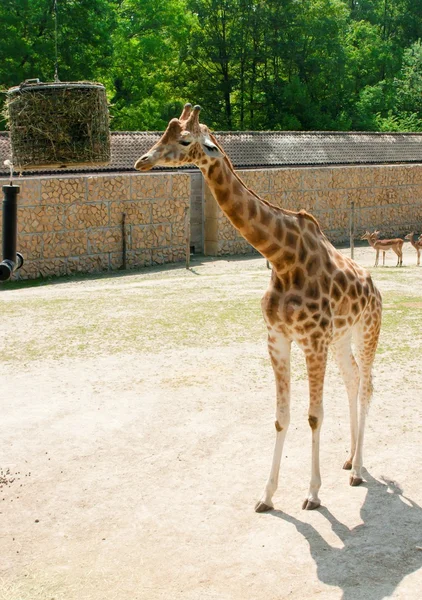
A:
[135,104,381,512]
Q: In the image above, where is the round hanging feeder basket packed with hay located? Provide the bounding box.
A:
[5,82,110,170]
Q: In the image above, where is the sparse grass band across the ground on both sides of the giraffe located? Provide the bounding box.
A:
[0,262,422,363]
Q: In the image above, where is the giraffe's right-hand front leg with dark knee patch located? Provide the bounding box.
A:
[302,348,327,510]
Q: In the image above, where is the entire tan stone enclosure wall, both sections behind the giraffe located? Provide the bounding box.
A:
[0,164,422,279]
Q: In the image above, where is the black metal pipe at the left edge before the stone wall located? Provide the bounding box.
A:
[0,184,23,281]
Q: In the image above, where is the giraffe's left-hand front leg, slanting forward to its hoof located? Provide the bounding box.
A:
[255,331,291,512]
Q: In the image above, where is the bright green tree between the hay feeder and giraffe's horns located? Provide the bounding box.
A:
[107,0,195,129]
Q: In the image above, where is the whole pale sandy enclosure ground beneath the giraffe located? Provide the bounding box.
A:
[0,245,422,600]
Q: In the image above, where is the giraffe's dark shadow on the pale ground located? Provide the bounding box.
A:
[269,471,422,600]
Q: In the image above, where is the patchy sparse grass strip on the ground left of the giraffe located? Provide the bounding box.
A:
[0,280,266,361]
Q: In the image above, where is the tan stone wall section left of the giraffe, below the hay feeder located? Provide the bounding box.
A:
[0,173,190,279]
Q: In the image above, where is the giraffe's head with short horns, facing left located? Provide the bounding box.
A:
[135,104,224,171]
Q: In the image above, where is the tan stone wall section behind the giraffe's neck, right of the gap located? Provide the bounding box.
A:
[205,164,422,256]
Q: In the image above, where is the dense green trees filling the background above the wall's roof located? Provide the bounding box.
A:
[0,0,422,131]
